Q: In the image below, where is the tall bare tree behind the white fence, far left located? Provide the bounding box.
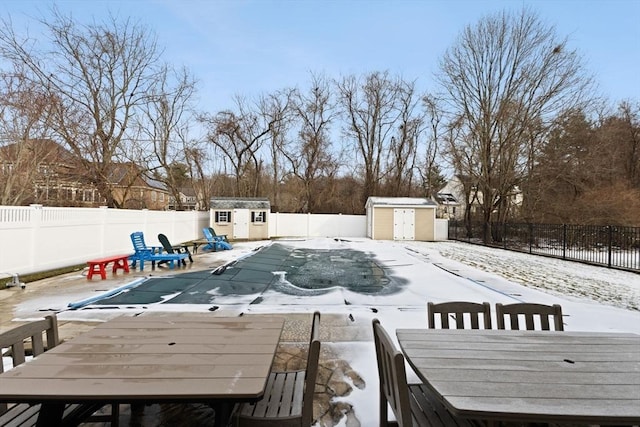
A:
[0,8,159,207]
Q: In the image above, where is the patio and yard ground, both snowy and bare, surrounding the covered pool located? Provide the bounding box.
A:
[0,239,640,427]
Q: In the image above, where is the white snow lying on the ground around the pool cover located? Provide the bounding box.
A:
[6,238,640,427]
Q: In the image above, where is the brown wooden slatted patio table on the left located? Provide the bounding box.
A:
[0,314,284,426]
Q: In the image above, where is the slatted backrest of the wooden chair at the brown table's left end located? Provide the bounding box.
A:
[0,314,60,414]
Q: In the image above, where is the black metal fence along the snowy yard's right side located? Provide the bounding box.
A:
[449,221,640,273]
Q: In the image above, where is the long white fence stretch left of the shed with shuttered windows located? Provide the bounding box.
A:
[0,205,209,277]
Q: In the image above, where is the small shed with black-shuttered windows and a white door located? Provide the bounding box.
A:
[209,197,271,240]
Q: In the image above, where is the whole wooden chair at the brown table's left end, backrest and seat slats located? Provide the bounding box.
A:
[0,314,119,427]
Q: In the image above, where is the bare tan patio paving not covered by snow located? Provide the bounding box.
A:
[0,244,373,427]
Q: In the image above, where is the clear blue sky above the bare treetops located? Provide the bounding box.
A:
[0,0,640,117]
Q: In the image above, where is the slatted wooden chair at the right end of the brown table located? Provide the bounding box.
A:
[236,311,320,427]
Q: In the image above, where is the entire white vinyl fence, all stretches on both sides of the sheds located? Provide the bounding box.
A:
[0,205,448,278]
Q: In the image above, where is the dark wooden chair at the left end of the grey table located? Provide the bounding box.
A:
[372,319,473,427]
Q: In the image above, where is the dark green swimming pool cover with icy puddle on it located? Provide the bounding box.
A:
[70,242,407,309]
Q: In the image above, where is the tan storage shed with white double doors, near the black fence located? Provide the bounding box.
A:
[366,197,438,241]
